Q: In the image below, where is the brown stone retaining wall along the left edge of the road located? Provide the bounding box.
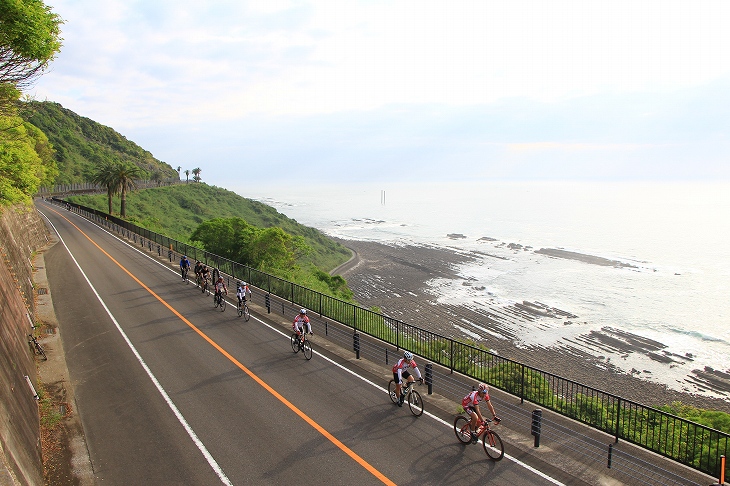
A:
[0,206,49,485]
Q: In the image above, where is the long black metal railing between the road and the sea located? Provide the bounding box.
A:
[54,198,730,478]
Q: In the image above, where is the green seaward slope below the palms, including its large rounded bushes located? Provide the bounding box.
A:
[69,183,352,300]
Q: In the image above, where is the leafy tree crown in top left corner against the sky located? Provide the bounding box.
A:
[0,0,63,108]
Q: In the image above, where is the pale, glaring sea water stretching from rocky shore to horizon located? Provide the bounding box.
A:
[232,182,730,391]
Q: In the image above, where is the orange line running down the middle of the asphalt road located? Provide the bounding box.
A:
[51,209,395,486]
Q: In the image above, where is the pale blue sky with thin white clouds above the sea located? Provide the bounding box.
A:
[27,0,730,187]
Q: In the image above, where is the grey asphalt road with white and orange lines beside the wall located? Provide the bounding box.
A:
[38,199,564,485]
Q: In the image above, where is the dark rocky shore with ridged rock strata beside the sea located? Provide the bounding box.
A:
[333,240,730,413]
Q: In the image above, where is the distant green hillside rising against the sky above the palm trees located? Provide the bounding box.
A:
[22,101,180,184]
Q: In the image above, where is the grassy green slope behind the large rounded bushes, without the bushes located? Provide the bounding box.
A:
[69,182,351,271]
